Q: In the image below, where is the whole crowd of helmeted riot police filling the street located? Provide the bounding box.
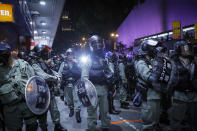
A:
[0,35,197,131]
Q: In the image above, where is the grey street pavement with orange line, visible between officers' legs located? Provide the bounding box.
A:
[44,97,140,131]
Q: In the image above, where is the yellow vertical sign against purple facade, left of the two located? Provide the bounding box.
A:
[172,21,181,39]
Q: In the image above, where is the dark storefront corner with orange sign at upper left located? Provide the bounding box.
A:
[0,0,32,49]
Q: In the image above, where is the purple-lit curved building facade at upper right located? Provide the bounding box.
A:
[117,0,197,47]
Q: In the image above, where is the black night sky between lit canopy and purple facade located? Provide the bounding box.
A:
[53,0,145,49]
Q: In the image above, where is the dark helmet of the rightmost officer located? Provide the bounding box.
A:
[174,41,193,57]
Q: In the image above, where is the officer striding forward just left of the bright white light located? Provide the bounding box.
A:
[58,48,81,123]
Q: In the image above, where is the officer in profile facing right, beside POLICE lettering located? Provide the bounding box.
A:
[134,39,169,131]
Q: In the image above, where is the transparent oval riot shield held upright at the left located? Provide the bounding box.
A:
[25,76,50,115]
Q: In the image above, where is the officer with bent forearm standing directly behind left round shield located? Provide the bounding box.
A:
[32,45,66,131]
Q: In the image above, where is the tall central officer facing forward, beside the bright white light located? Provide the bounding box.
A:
[82,35,112,131]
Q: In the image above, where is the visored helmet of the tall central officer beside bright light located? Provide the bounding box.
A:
[89,35,104,56]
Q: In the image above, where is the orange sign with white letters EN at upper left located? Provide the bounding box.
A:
[0,4,14,22]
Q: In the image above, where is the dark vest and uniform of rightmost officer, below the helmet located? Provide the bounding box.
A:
[168,56,197,131]
